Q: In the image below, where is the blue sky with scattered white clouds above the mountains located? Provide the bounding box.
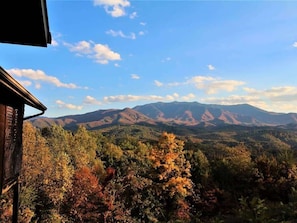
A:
[0,0,297,117]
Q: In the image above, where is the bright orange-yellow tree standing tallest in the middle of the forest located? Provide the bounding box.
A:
[150,132,193,222]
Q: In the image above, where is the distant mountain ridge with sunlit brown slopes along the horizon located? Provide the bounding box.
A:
[31,102,297,129]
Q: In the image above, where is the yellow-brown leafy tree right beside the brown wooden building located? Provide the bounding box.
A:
[19,122,73,222]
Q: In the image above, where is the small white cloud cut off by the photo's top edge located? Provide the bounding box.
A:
[94,0,130,17]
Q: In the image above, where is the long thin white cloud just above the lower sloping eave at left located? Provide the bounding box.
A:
[7,68,80,89]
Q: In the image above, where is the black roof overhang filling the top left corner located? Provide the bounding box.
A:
[0,0,51,47]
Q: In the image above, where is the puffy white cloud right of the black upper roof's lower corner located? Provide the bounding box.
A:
[64,41,121,64]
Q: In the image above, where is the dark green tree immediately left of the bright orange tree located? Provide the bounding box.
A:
[104,141,161,223]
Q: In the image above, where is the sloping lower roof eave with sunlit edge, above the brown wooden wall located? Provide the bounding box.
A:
[0,66,47,112]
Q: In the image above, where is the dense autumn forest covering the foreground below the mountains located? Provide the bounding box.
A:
[0,122,297,223]
